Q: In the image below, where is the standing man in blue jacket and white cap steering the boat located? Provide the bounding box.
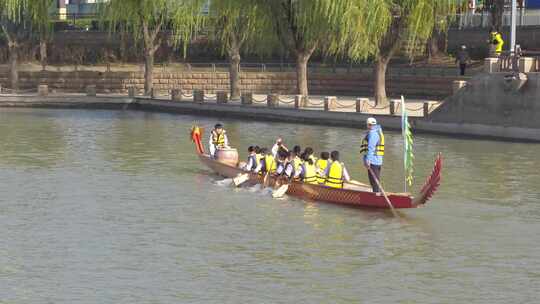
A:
[360,117,384,193]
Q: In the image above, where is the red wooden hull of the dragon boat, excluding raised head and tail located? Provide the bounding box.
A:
[199,154,417,209]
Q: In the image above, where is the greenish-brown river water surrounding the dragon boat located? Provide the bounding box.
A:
[0,109,540,303]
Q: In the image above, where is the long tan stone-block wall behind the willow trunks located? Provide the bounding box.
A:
[0,71,456,98]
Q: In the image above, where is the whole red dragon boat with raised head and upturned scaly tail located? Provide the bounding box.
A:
[191,127,443,209]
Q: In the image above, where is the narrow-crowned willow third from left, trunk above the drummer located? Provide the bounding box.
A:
[209,0,273,99]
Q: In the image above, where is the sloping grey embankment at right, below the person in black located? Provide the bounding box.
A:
[429,72,540,129]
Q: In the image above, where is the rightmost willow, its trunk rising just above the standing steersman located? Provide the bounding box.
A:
[349,0,462,105]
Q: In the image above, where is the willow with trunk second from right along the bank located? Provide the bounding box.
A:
[253,0,355,96]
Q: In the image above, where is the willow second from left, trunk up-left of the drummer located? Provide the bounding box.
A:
[101,0,206,94]
